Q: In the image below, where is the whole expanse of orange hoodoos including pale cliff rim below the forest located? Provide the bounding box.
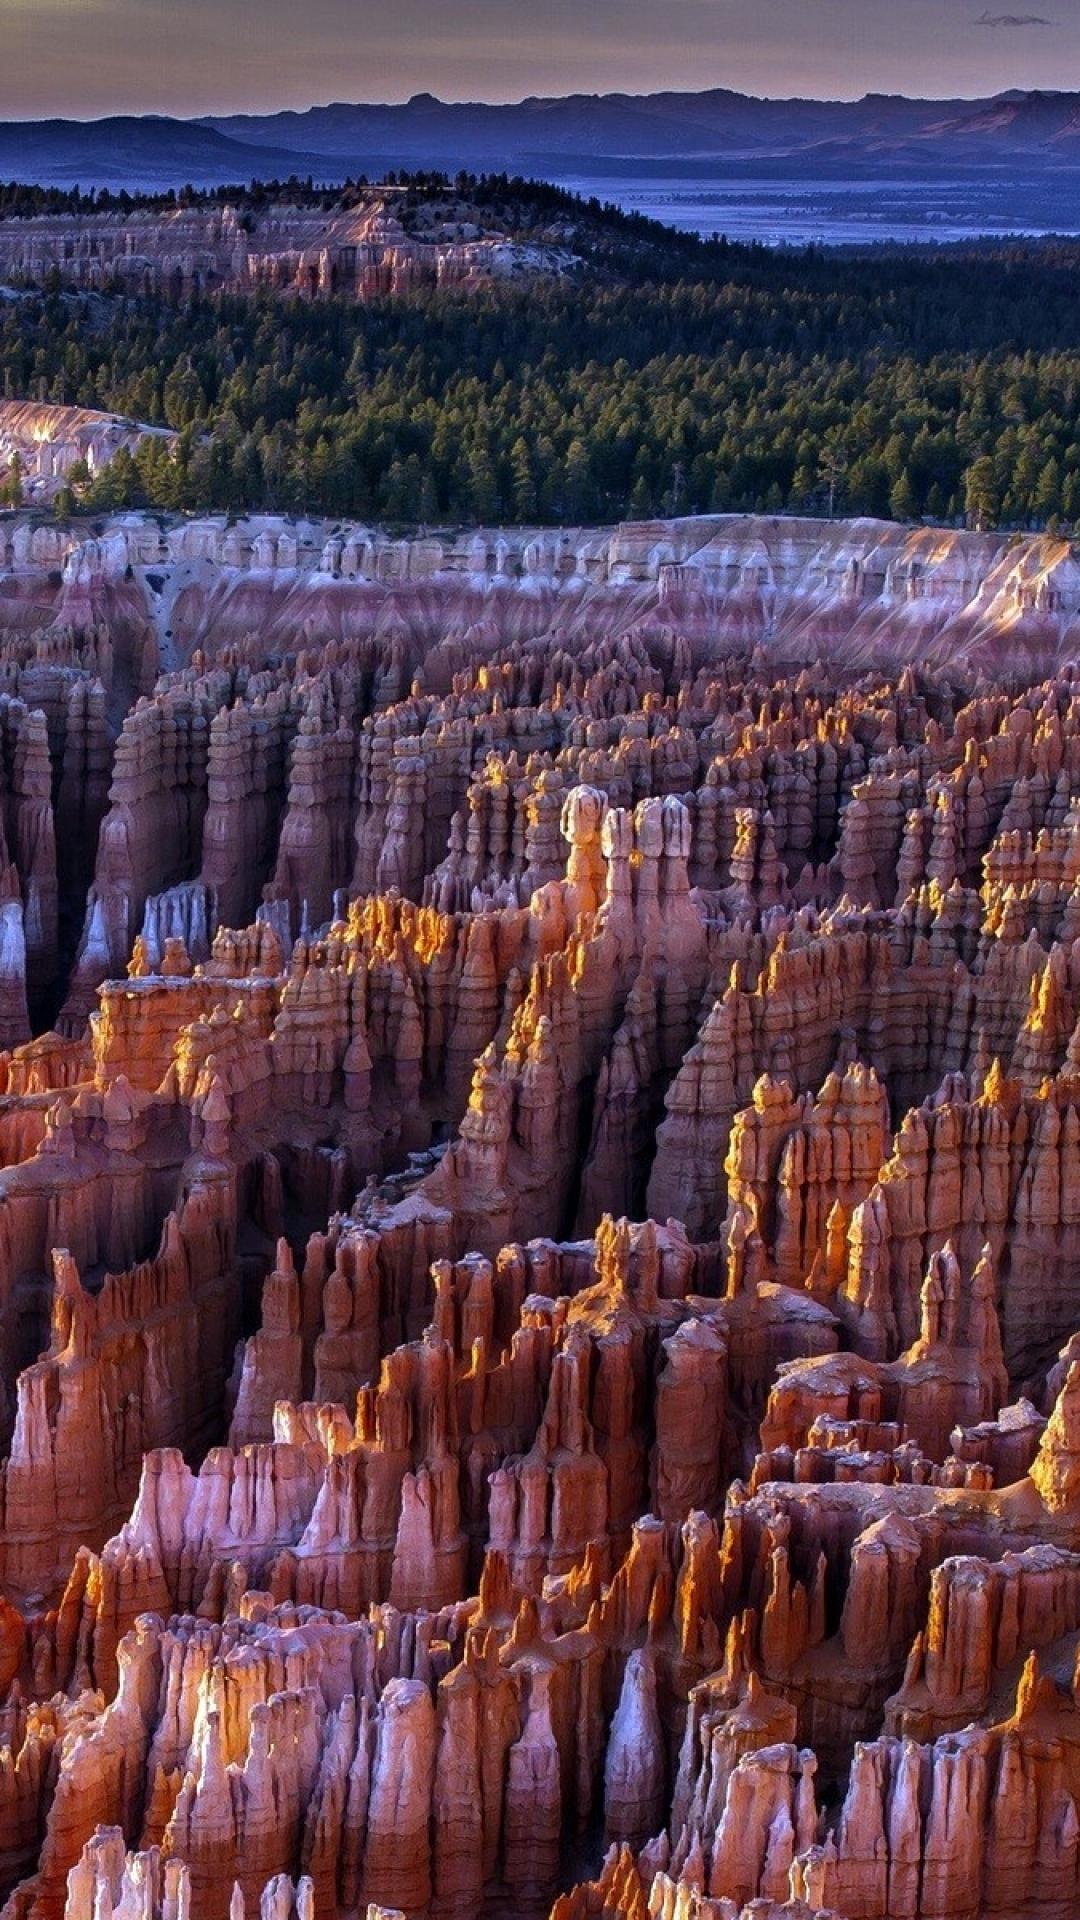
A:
[0,520,1080,1920]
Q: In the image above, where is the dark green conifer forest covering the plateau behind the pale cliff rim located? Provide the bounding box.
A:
[12,190,1080,528]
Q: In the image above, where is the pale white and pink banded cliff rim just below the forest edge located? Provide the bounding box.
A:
[0,510,1080,675]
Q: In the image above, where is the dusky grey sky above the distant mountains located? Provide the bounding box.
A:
[0,0,1080,119]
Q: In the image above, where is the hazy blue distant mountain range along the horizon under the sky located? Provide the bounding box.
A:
[0,88,1080,188]
